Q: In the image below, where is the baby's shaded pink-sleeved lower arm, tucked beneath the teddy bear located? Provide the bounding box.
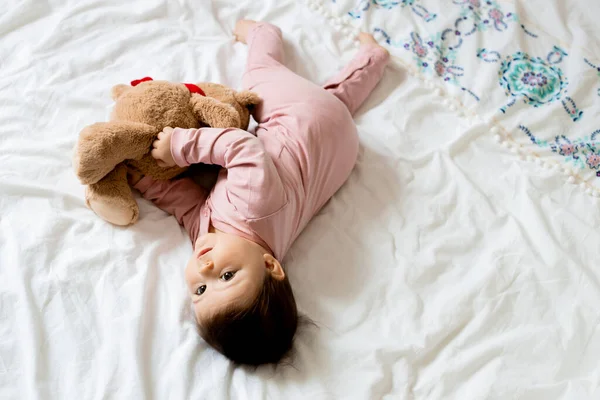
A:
[134,176,208,242]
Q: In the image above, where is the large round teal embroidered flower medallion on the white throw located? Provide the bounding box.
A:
[498,52,567,107]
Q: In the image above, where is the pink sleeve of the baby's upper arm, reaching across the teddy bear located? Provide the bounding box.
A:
[166,128,287,219]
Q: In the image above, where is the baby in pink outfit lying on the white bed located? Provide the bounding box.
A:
[130,20,389,365]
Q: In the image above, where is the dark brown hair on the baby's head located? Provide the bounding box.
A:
[198,275,298,366]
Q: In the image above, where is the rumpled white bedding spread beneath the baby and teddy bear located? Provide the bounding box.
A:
[0,0,600,399]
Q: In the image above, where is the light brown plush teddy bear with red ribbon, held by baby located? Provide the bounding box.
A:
[73,77,260,226]
